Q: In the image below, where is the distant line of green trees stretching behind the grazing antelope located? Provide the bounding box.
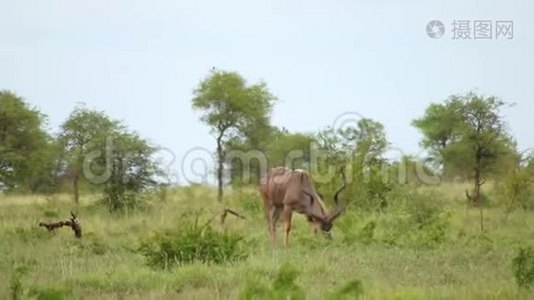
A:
[0,69,534,210]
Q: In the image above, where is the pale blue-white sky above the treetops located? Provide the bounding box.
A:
[0,0,534,183]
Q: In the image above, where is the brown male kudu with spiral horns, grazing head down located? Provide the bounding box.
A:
[260,167,347,247]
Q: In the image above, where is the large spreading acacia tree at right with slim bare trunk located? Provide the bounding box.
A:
[413,92,516,228]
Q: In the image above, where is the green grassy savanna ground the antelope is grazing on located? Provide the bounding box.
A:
[0,184,534,299]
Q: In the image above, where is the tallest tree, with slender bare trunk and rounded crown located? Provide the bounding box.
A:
[192,70,276,201]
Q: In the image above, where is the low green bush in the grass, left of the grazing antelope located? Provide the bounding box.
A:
[139,223,247,269]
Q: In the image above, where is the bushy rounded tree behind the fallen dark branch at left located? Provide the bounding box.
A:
[59,106,161,212]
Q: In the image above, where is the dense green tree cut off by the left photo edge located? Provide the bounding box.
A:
[0,91,57,192]
